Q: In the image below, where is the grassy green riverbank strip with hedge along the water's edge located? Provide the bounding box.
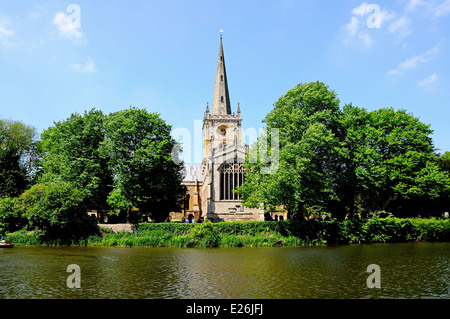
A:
[6,217,450,247]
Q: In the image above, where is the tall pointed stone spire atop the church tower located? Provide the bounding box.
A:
[211,31,231,115]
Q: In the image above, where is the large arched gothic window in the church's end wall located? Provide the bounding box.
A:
[220,163,246,200]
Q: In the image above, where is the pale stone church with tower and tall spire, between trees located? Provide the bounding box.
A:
[170,34,264,222]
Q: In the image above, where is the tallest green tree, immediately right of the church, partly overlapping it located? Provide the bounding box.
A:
[238,82,339,215]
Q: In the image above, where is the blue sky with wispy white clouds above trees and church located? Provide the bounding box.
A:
[0,0,450,163]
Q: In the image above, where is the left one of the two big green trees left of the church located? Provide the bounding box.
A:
[39,109,112,210]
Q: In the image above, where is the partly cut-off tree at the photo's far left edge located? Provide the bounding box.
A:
[0,120,37,197]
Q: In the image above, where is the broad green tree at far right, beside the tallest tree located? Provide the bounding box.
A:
[336,105,448,219]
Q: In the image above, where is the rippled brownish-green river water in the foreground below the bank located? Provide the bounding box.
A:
[0,243,450,299]
